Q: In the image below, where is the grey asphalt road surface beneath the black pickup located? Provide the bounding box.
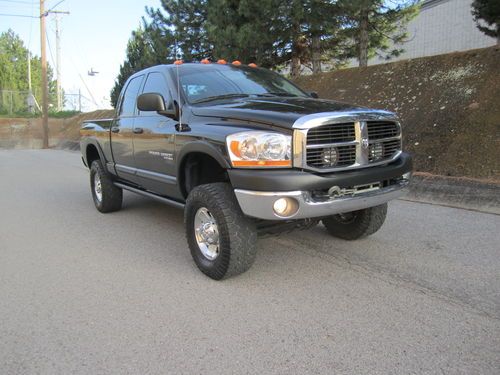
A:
[0,150,500,374]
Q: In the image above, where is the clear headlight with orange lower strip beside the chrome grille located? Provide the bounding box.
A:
[226,131,292,168]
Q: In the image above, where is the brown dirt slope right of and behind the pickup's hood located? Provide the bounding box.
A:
[297,47,500,181]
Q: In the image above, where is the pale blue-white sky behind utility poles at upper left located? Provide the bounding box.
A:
[0,0,160,111]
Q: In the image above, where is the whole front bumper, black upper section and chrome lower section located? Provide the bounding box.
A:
[229,153,412,220]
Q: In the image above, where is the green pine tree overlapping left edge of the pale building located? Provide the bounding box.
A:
[338,0,418,67]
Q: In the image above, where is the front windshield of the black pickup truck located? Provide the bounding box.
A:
[179,65,308,104]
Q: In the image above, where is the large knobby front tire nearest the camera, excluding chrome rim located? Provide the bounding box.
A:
[184,183,257,280]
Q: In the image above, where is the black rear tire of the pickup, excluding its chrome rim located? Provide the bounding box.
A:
[90,160,123,213]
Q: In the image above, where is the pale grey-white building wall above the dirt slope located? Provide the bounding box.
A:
[369,0,500,65]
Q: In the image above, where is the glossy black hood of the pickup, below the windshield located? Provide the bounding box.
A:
[191,97,378,129]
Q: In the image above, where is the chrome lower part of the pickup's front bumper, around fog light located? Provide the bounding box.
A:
[234,180,409,220]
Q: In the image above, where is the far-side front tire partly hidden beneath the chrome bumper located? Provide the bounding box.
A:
[322,203,387,240]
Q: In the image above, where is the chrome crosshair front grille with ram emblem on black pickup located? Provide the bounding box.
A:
[294,114,401,172]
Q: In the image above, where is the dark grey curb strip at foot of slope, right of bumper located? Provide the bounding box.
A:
[403,173,500,215]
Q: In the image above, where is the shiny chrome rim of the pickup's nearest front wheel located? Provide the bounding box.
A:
[194,207,220,260]
